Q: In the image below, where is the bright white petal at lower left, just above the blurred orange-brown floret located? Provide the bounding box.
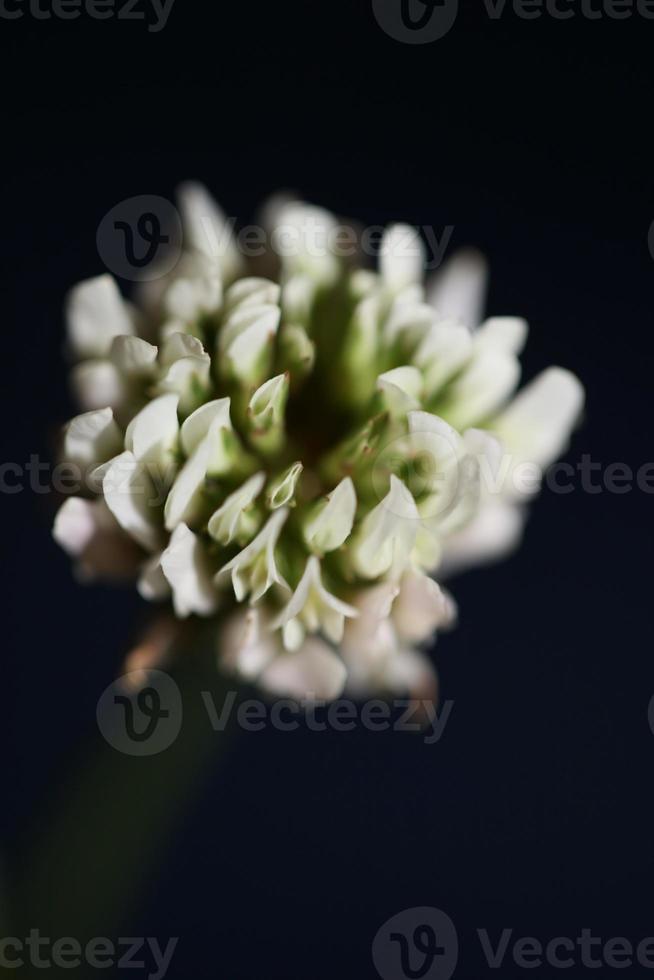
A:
[161,524,219,618]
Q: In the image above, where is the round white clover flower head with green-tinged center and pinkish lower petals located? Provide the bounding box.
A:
[54,184,583,698]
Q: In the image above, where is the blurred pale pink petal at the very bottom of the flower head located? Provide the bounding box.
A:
[259,637,347,701]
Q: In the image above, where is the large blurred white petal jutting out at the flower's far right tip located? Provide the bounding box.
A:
[492,368,584,466]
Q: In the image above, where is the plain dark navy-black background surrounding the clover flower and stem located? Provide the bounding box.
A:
[0,0,654,980]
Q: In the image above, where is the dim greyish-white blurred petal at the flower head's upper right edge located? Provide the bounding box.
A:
[427,250,488,328]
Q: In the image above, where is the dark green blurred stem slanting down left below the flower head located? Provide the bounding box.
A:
[12,628,237,941]
